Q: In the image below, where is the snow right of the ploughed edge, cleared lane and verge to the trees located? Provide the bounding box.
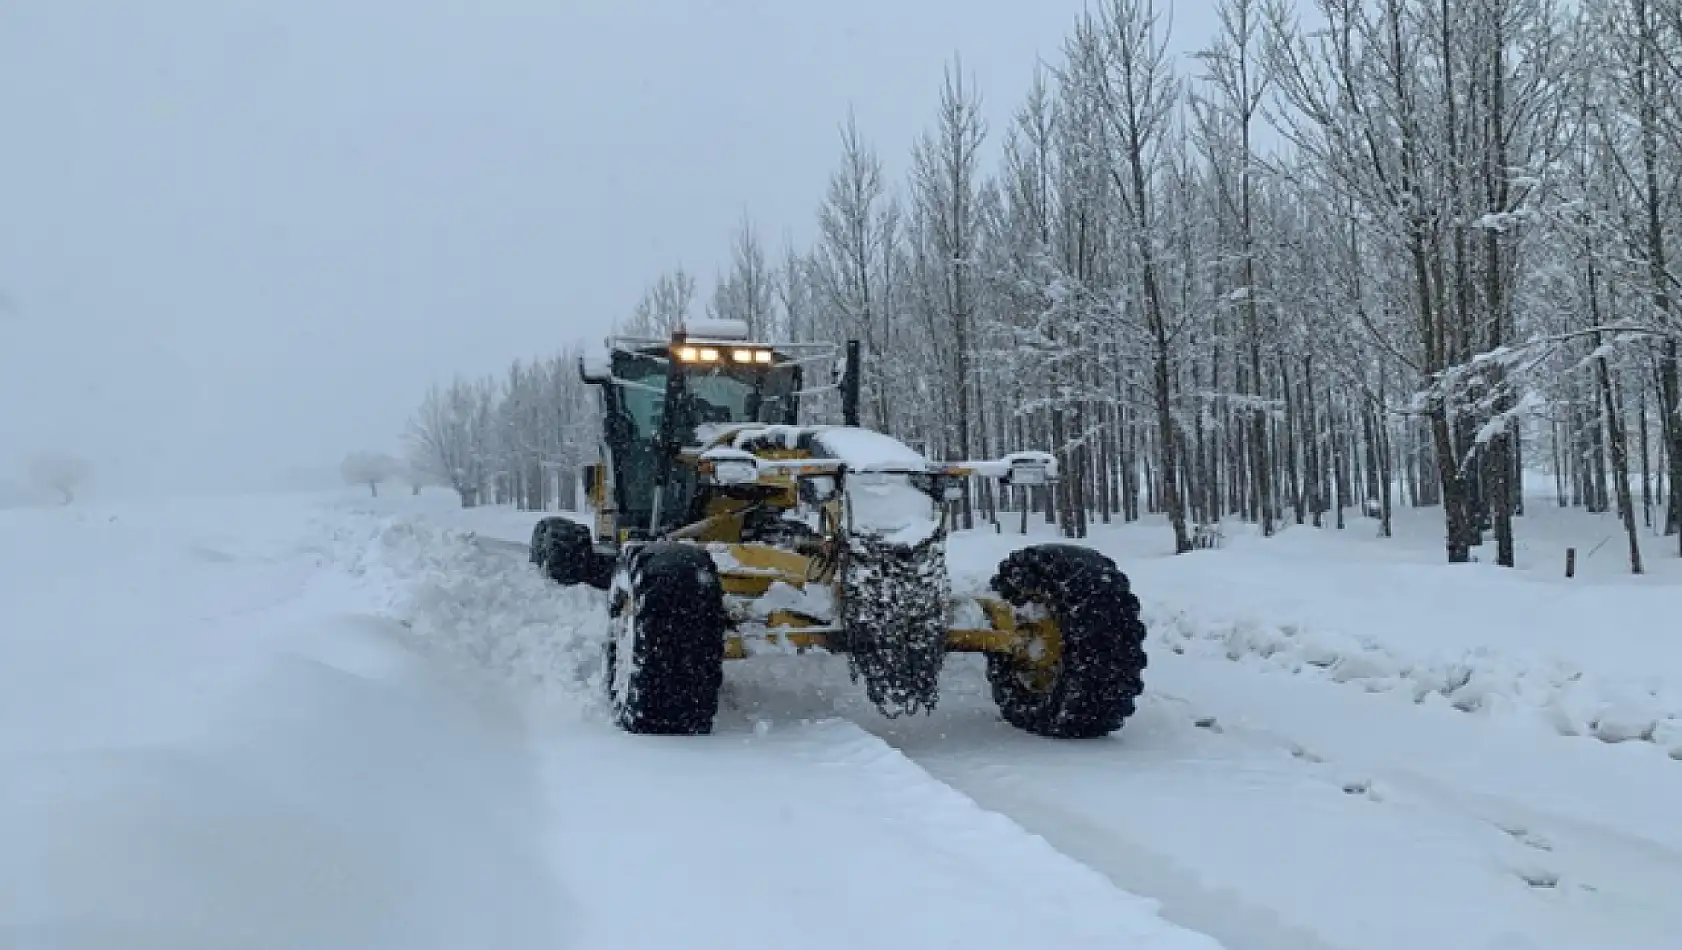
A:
[444,484,1682,950]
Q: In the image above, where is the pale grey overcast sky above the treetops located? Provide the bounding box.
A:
[0,0,1213,494]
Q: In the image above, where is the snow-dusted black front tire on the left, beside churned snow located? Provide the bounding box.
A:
[606,541,730,735]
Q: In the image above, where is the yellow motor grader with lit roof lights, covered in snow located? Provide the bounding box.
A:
[532,319,1145,738]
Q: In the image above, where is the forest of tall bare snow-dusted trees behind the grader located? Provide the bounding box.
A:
[414,0,1682,572]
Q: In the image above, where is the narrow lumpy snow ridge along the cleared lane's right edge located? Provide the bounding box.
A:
[1145,600,1682,760]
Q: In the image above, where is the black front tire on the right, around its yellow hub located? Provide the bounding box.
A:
[987,545,1147,738]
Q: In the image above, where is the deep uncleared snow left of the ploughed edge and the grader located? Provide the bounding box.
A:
[0,496,1216,950]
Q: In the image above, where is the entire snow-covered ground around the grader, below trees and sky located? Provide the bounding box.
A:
[0,493,1682,950]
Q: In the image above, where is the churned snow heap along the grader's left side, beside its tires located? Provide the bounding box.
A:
[321,516,604,715]
